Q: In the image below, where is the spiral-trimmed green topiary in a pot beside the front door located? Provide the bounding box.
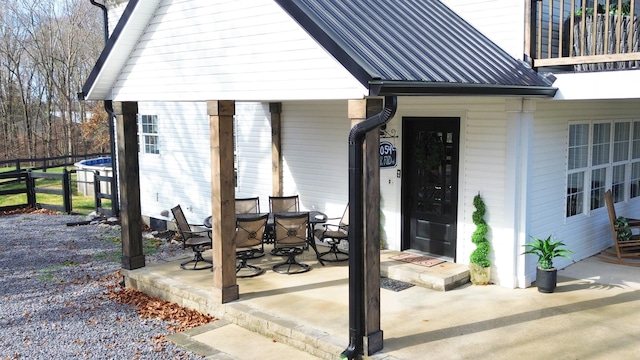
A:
[469,193,491,285]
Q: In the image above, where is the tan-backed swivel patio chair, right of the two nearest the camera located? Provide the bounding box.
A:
[273,212,311,274]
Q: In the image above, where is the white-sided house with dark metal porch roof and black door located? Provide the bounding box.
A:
[83,0,640,287]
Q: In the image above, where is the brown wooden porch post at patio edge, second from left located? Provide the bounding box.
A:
[207,100,239,304]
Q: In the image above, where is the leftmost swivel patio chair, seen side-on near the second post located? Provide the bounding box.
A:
[171,205,213,270]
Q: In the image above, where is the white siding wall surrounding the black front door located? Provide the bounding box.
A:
[392,97,514,283]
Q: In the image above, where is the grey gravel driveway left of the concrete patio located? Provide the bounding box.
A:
[0,214,201,359]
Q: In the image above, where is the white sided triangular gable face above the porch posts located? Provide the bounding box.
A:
[113,0,367,101]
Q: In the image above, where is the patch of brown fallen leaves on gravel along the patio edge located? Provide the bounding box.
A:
[106,271,216,332]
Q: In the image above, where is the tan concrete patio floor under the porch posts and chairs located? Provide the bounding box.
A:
[123,248,640,360]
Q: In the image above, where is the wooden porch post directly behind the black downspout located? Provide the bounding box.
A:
[348,99,383,355]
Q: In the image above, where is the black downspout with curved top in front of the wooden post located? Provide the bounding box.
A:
[341,96,398,359]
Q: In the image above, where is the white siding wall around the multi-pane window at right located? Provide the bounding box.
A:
[526,100,640,277]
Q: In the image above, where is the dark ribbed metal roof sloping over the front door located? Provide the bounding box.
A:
[275,0,556,96]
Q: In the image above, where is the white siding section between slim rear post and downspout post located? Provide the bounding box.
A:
[282,100,351,217]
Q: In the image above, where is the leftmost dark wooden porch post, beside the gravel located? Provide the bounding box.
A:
[113,102,145,270]
